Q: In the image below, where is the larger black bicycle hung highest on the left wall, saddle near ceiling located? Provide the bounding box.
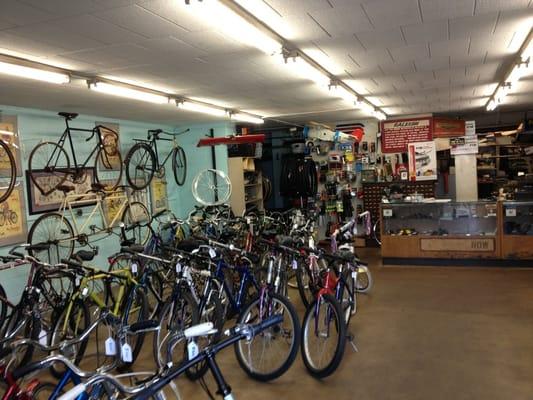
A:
[29,112,122,196]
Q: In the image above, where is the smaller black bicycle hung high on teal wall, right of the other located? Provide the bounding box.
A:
[125,129,189,190]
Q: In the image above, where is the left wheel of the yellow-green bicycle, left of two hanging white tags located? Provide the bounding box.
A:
[50,299,91,379]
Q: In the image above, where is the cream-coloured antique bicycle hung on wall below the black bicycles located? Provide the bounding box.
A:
[28,184,150,264]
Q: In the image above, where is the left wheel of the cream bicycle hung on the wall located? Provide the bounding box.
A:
[28,213,76,264]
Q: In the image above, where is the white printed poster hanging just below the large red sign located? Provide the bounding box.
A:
[408,141,437,181]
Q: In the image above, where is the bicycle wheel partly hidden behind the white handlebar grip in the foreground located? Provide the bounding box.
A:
[185,291,224,380]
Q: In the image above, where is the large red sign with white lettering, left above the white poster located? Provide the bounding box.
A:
[381,117,433,153]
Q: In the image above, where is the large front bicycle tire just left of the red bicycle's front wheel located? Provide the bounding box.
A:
[234,292,301,382]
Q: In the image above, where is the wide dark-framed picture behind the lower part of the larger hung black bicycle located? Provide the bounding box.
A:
[26,167,96,215]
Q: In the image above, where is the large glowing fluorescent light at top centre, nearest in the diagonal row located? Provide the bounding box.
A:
[185,0,282,55]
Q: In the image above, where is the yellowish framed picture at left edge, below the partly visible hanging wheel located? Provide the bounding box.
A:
[0,182,28,246]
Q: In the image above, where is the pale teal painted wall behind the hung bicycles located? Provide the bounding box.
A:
[0,105,234,301]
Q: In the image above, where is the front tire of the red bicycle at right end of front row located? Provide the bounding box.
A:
[301,294,346,379]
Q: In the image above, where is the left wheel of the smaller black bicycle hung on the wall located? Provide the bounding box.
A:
[126,143,156,190]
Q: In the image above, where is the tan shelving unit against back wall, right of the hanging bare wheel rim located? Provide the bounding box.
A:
[228,157,264,215]
